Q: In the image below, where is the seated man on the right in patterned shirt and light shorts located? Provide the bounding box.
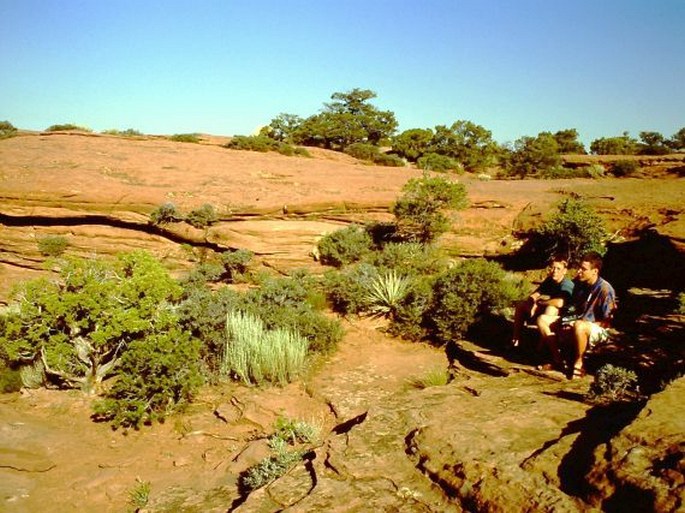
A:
[543,251,616,379]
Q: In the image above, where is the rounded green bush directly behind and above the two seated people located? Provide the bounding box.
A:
[533,198,608,263]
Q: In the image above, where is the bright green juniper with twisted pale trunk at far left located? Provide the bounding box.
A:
[0,252,181,391]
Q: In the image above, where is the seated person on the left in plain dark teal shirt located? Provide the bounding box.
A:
[511,255,573,347]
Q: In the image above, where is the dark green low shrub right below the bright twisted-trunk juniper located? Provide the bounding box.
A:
[93,329,204,429]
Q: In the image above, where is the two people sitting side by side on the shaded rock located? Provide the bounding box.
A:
[511,251,616,378]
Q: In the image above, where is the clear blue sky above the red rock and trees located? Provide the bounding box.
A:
[0,0,685,144]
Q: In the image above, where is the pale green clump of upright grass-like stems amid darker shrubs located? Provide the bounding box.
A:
[221,311,308,385]
